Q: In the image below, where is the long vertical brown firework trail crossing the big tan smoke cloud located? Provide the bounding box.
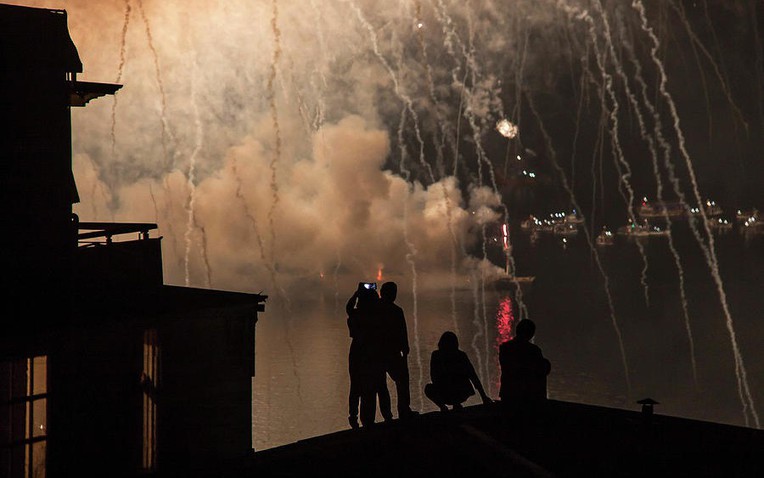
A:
[267,0,281,276]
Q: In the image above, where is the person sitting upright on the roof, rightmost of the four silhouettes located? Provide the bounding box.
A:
[499,319,552,411]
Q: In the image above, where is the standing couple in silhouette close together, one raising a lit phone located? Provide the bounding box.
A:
[345,282,415,428]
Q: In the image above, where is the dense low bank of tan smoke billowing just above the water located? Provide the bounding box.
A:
[74,116,498,290]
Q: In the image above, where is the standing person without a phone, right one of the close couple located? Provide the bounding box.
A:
[379,282,416,418]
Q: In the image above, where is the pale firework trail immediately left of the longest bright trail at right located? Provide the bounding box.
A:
[621,15,698,388]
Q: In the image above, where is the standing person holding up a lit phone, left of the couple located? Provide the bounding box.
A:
[345,283,392,428]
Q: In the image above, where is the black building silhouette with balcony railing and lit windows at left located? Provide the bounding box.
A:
[0,5,266,478]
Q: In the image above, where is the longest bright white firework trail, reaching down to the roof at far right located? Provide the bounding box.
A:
[631,0,761,428]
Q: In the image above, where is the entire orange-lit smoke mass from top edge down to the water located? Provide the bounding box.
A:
[19,0,524,293]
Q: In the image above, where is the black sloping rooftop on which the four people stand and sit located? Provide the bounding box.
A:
[195,401,764,477]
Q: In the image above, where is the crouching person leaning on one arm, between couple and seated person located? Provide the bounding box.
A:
[424,331,492,412]
